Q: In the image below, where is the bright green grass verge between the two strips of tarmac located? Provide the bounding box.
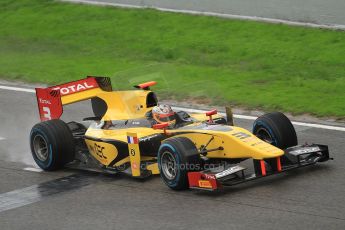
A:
[0,0,345,117]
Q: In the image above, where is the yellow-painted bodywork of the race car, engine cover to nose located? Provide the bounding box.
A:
[57,80,284,176]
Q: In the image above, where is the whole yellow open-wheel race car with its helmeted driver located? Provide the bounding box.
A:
[30,77,330,191]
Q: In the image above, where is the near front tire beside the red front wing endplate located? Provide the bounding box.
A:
[157,137,201,190]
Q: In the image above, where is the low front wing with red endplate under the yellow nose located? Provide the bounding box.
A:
[188,144,332,191]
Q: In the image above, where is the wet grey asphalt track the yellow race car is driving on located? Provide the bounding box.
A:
[0,81,345,230]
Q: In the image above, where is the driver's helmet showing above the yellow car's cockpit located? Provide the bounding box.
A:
[152,104,176,128]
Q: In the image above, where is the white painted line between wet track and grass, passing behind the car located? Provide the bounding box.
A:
[0,85,345,132]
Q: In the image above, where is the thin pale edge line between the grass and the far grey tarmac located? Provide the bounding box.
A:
[60,0,345,30]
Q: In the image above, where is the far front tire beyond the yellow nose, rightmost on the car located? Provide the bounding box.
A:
[253,112,297,150]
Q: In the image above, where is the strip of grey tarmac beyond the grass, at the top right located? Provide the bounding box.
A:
[60,0,345,30]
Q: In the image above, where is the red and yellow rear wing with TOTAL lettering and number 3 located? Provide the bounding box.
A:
[36,77,112,121]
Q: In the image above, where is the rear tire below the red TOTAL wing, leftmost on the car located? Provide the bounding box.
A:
[30,120,75,171]
